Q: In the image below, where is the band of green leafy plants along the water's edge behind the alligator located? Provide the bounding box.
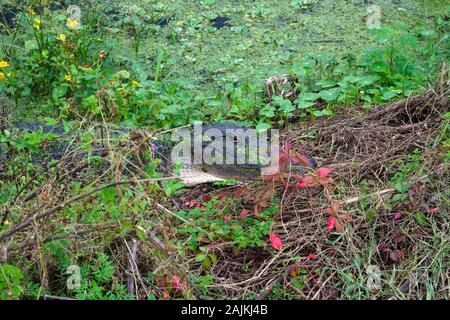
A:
[0,1,448,130]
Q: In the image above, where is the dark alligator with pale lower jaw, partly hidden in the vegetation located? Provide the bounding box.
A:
[0,122,317,185]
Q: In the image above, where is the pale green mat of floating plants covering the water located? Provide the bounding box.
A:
[125,0,445,90]
